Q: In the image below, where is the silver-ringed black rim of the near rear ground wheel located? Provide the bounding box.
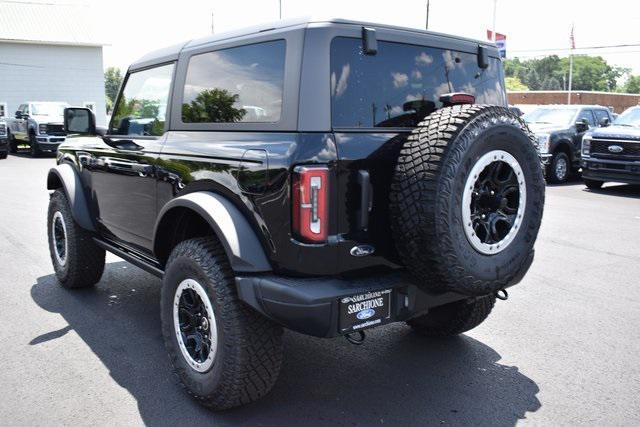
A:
[173,279,218,372]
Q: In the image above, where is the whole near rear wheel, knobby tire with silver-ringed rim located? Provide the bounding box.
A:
[160,237,282,410]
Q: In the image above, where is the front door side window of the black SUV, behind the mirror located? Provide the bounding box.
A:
[109,64,174,136]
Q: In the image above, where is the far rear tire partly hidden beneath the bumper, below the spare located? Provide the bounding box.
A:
[407,295,496,337]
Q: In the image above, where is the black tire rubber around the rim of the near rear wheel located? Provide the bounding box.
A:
[161,237,282,410]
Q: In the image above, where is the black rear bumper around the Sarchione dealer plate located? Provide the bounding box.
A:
[236,273,468,337]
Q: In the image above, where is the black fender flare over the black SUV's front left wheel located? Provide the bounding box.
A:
[47,163,96,231]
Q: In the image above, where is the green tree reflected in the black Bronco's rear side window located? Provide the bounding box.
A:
[182,89,247,123]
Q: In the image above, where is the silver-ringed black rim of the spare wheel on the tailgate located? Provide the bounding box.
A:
[462,150,527,255]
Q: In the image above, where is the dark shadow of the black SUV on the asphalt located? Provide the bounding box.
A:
[30,262,541,426]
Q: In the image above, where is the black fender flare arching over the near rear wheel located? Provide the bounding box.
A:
[153,191,271,273]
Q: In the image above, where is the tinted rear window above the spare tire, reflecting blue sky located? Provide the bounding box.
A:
[331,37,506,128]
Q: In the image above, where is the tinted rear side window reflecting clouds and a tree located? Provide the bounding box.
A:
[182,40,285,123]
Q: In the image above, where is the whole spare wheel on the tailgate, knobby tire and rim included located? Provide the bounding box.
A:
[390,105,545,295]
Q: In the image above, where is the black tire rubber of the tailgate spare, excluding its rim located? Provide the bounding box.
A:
[390,105,545,296]
